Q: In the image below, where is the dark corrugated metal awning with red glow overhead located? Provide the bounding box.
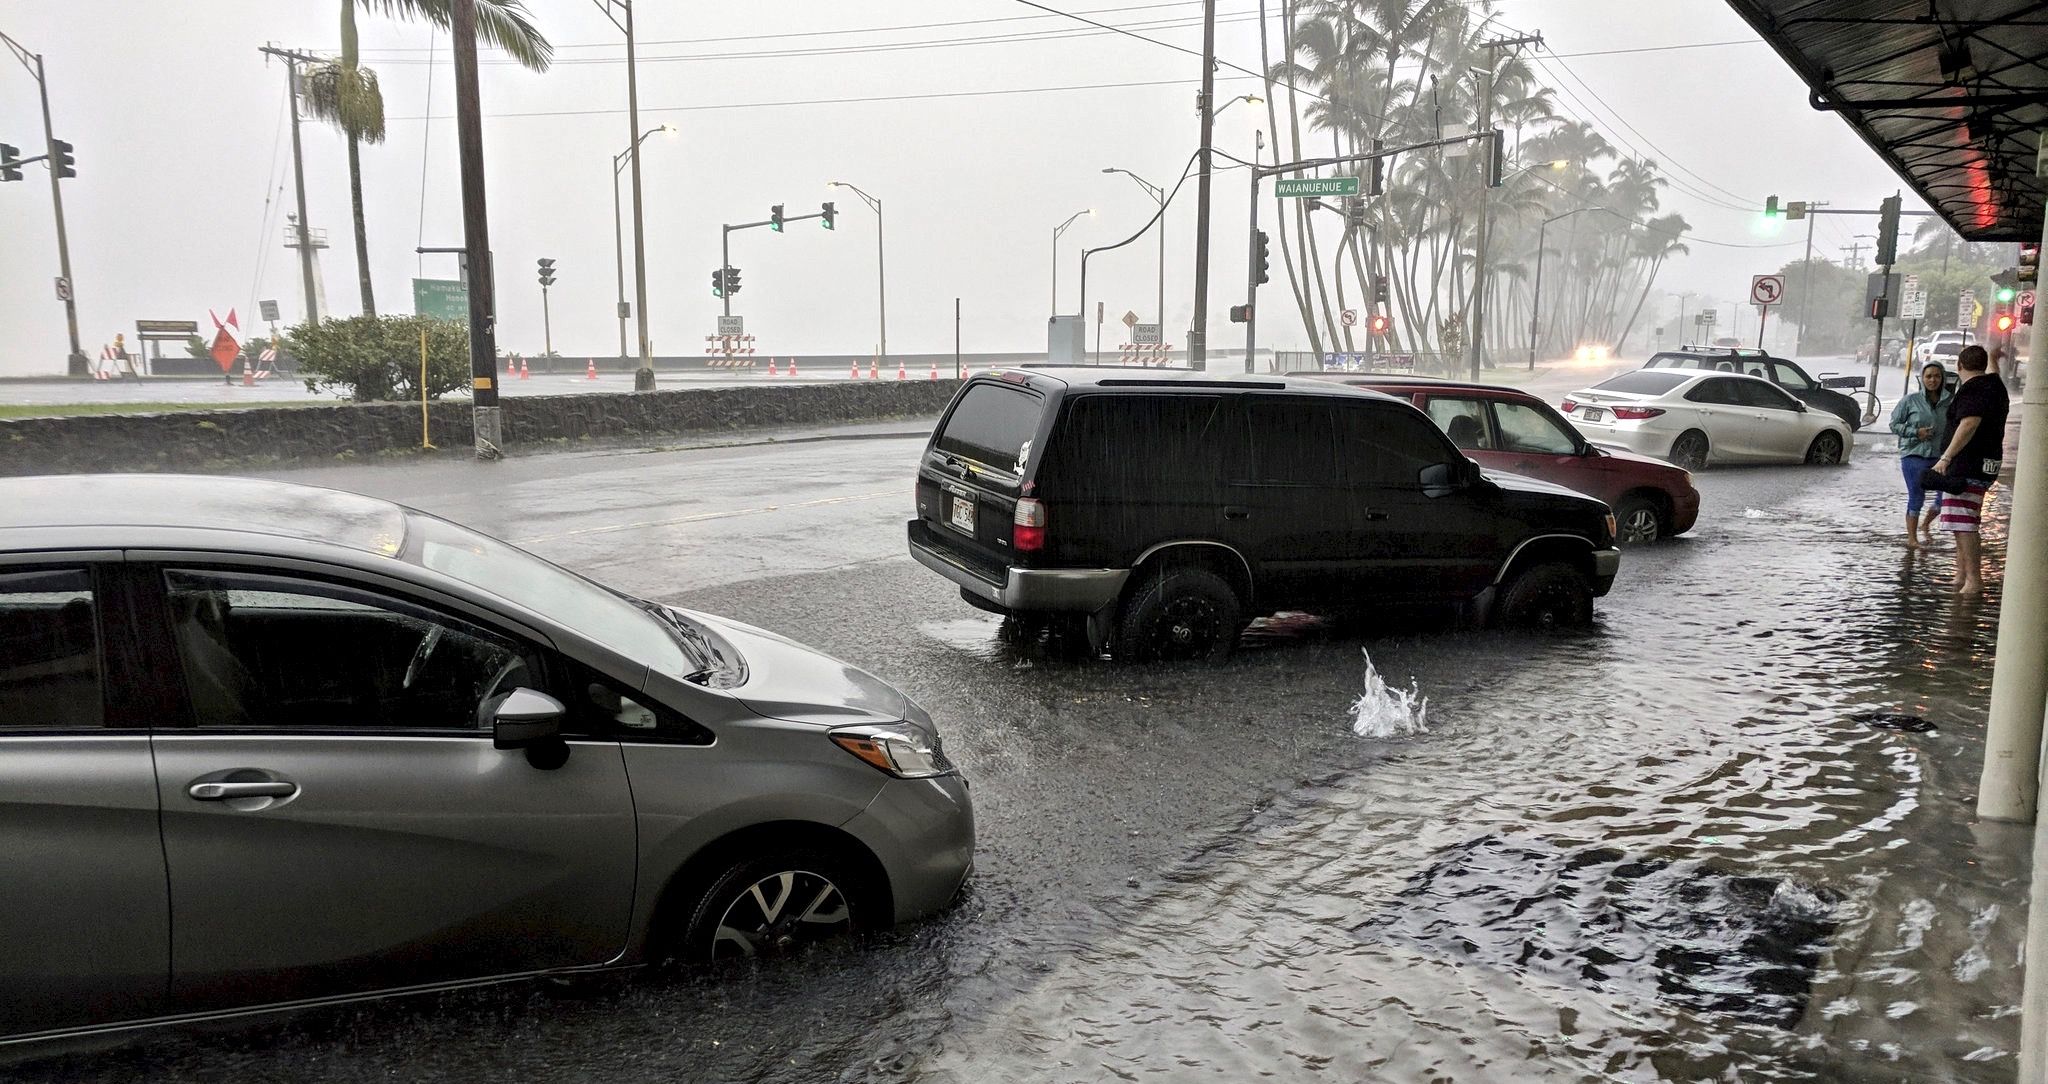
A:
[1729,0,2048,242]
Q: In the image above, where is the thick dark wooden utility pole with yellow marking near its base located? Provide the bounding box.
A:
[452,0,499,459]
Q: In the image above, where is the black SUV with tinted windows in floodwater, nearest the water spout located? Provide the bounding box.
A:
[909,367,1620,658]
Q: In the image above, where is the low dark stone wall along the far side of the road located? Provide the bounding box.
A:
[0,379,958,475]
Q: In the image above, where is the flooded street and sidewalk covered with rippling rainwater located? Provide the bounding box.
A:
[12,411,2028,1082]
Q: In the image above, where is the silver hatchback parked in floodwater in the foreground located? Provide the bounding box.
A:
[0,475,973,1041]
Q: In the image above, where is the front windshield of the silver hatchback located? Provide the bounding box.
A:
[403,514,711,678]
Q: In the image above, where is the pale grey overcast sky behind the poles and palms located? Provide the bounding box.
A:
[0,0,1919,373]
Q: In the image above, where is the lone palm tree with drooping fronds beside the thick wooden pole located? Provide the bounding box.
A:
[303,0,555,316]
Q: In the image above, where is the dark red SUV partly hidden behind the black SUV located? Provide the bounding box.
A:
[1292,373,1700,543]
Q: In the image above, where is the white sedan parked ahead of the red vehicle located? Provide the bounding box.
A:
[1561,369,1851,471]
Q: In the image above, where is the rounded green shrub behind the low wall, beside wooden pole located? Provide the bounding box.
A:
[281,316,469,402]
